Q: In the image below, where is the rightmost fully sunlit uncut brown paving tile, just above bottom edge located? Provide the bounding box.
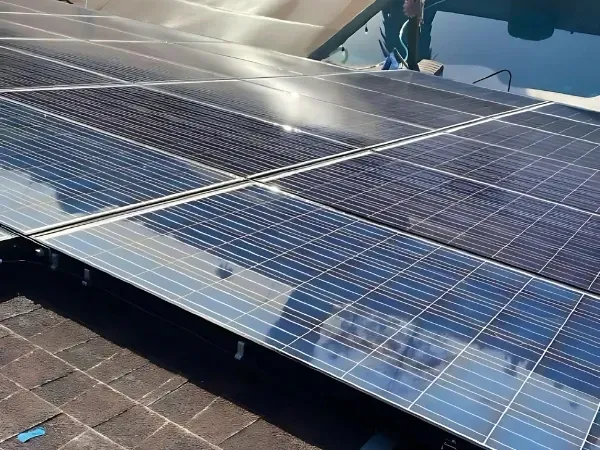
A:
[186,398,259,445]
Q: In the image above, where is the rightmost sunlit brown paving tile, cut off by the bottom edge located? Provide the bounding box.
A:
[221,419,317,450]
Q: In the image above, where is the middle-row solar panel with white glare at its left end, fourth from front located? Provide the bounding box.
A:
[248,75,478,129]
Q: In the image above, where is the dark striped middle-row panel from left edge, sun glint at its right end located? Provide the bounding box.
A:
[4,88,351,175]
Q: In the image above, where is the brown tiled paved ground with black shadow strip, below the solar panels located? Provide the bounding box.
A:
[0,273,375,450]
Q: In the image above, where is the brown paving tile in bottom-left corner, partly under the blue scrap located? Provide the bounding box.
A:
[0,414,87,450]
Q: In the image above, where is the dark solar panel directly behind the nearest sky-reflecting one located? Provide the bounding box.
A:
[274,149,600,293]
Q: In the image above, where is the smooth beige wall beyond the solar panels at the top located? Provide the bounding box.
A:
[74,0,375,56]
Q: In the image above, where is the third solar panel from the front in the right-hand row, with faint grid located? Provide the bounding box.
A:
[376,134,600,212]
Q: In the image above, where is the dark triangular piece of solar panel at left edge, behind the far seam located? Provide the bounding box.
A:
[0,47,114,89]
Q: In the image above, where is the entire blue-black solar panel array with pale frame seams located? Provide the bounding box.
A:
[0,0,600,450]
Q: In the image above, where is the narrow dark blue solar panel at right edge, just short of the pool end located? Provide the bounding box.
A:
[503,111,600,144]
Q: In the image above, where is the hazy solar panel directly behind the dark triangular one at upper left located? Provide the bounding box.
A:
[6,41,220,82]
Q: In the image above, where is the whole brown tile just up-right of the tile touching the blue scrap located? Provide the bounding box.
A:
[62,385,134,427]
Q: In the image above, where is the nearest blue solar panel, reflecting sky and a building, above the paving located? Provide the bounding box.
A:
[42,183,600,449]
